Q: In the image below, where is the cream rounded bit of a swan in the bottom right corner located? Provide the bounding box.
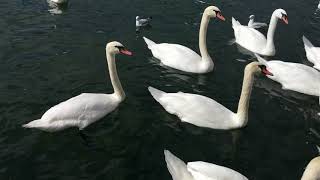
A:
[301,157,320,180]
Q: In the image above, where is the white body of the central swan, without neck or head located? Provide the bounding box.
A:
[149,87,238,129]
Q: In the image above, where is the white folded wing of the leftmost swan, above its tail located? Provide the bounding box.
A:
[41,93,119,121]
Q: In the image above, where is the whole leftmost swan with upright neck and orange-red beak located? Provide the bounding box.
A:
[23,41,132,132]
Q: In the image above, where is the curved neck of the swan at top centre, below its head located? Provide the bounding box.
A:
[199,13,212,61]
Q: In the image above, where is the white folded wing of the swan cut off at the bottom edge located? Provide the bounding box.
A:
[187,161,248,180]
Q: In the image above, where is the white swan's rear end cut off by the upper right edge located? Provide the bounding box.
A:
[302,36,320,70]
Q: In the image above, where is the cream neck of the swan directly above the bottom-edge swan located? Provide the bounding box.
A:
[237,64,254,127]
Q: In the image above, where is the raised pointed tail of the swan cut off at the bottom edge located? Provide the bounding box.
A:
[164,150,193,180]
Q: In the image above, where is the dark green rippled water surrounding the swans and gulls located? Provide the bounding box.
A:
[0,0,320,180]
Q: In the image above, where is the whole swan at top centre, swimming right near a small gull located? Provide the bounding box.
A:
[143,6,225,73]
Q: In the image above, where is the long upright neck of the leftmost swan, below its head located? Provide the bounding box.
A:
[107,52,126,101]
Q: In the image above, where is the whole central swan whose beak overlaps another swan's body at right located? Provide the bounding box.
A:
[148,62,272,130]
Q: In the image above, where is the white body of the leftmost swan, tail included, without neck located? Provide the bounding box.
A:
[23,93,120,132]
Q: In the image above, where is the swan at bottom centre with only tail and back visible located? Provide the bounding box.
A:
[164,150,248,180]
